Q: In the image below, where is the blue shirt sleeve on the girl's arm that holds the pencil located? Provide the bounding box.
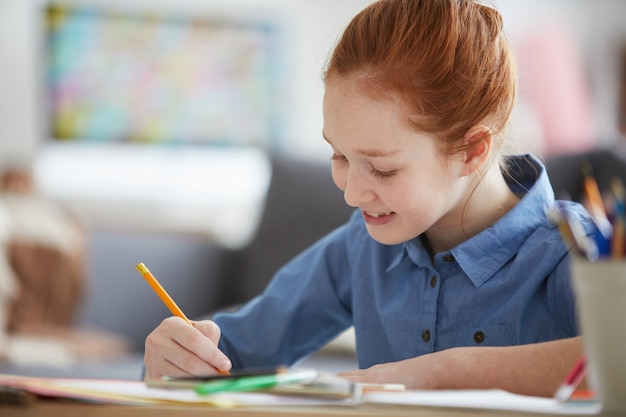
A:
[214,218,352,368]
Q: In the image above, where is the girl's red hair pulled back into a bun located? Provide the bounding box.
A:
[324,0,516,153]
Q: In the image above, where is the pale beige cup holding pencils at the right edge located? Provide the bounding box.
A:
[571,258,626,415]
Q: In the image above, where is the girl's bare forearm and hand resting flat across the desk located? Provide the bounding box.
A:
[339,336,586,397]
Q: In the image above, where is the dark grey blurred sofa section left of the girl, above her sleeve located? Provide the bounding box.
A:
[225,154,354,304]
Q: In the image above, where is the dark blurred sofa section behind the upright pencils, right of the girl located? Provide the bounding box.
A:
[546,149,626,201]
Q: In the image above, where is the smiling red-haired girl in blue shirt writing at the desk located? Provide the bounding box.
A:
[145,0,592,395]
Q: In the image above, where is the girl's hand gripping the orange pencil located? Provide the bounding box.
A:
[144,317,232,379]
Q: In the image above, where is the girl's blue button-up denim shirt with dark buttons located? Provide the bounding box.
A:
[215,156,593,368]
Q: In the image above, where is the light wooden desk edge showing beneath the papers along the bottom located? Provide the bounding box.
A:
[0,400,588,417]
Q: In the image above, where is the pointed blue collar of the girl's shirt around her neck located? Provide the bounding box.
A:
[389,155,554,287]
